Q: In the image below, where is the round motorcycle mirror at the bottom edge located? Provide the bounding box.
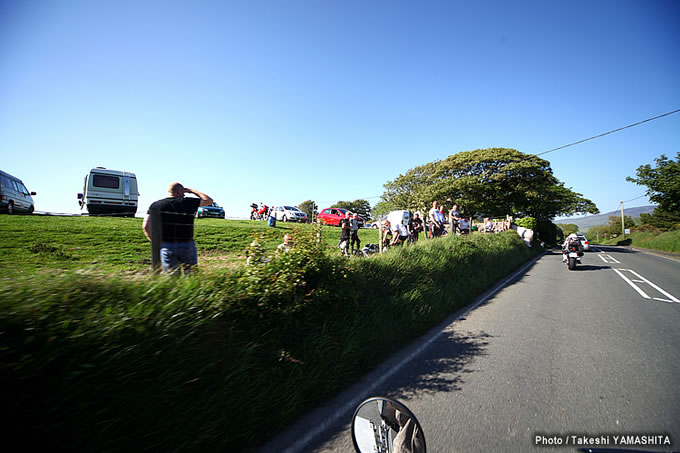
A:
[352,397,427,453]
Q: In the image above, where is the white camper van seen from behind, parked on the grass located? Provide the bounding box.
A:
[78,167,139,217]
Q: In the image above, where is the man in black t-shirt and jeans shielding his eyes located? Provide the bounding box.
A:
[142,182,213,273]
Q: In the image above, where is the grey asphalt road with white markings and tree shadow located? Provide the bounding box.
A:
[262,247,680,452]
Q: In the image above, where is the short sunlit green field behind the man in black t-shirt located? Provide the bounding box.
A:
[0,215,378,277]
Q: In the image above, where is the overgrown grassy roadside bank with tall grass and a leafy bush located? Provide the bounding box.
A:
[0,215,533,451]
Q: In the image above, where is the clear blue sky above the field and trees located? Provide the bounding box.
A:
[0,0,680,217]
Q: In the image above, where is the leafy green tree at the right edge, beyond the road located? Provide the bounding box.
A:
[626,152,680,212]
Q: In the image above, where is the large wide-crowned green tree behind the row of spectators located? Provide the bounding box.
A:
[382,148,599,220]
